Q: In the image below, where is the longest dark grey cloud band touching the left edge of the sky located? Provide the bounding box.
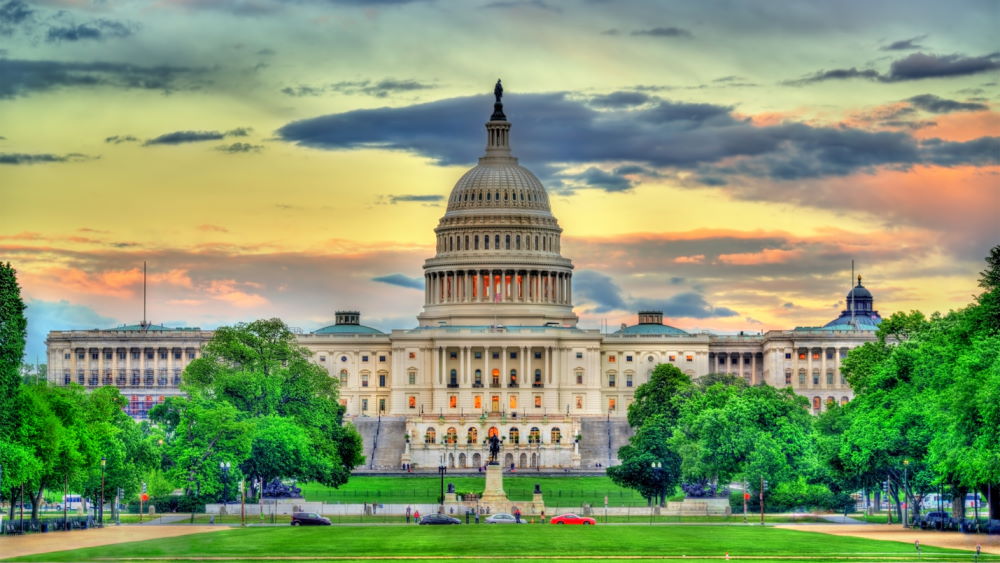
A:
[0,59,203,99]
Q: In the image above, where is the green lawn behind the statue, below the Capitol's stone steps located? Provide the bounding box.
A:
[300,475,646,506]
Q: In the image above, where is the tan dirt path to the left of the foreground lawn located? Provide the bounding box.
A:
[0,526,229,558]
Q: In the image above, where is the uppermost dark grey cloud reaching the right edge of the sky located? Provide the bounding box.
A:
[785,52,1000,85]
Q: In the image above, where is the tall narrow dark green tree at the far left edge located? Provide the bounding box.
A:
[0,262,28,438]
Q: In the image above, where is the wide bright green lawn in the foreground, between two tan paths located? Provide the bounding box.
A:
[5,525,984,562]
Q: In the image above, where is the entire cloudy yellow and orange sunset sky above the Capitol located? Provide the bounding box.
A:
[0,0,1000,361]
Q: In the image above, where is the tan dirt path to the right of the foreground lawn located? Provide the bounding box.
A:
[775,524,1000,554]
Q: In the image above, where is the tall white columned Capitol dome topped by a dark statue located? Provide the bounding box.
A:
[418,81,577,326]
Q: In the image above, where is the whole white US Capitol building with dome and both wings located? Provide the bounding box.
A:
[46,83,880,470]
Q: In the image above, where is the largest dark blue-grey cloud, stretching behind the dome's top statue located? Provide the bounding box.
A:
[277,93,988,191]
